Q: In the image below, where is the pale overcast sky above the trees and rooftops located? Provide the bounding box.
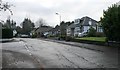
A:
[0,0,119,26]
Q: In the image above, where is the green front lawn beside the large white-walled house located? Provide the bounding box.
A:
[76,37,106,42]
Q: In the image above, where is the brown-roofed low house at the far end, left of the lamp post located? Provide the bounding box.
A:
[35,26,52,37]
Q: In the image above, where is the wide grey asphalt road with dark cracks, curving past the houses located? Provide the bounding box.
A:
[2,38,118,68]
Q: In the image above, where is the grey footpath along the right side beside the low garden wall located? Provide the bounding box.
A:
[42,39,118,52]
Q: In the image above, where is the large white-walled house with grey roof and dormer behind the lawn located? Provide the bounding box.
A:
[67,16,102,36]
